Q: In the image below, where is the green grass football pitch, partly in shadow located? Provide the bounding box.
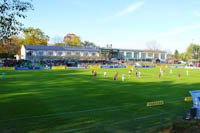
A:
[0,68,200,133]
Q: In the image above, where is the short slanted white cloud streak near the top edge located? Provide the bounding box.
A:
[117,2,144,16]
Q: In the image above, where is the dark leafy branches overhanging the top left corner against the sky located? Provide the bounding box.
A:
[0,0,33,42]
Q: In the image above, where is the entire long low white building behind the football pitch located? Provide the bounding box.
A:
[21,45,167,62]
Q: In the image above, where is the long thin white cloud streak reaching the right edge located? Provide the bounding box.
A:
[153,24,200,38]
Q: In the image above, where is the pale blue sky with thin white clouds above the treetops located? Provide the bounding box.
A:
[23,0,200,52]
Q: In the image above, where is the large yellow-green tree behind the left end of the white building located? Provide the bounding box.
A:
[19,27,49,45]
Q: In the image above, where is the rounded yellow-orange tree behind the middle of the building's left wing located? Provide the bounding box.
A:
[64,34,81,46]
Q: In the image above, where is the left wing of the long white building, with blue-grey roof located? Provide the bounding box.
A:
[21,45,100,61]
